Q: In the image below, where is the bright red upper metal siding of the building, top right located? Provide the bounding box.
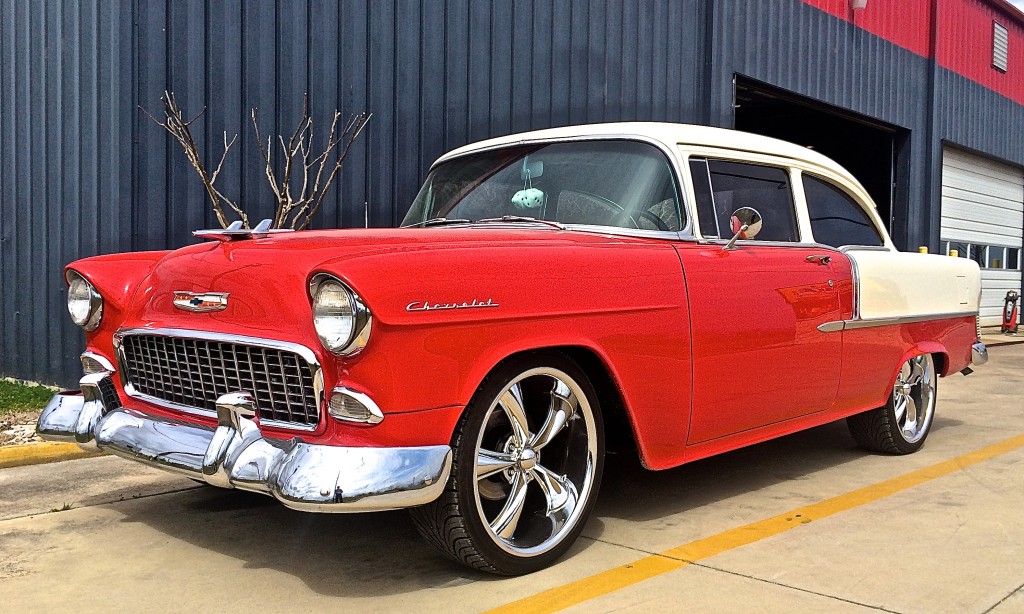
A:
[804,0,1024,104]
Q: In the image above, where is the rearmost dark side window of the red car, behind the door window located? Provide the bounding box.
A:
[804,175,885,248]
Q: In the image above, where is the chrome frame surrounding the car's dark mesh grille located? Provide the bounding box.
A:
[114,327,324,431]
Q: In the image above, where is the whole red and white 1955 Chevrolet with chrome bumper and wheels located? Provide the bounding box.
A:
[38,123,987,574]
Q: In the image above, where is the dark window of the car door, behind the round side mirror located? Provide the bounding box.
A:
[690,159,799,242]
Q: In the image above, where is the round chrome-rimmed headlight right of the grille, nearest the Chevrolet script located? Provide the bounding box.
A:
[311,275,371,356]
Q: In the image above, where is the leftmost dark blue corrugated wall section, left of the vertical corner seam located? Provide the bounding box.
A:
[0,0,134,382]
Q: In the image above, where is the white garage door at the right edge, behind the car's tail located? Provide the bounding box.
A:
[942,146,1024,326]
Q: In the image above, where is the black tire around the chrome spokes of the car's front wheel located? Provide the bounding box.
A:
[411,352,604,576]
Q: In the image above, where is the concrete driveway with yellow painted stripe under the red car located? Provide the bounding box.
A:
[0,345,1024,614]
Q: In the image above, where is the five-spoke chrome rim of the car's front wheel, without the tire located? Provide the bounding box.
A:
[474,367,597,556]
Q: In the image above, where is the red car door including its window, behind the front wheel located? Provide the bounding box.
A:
[677,159,849,444]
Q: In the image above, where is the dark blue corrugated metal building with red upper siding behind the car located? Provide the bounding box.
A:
[0,0,1024,384]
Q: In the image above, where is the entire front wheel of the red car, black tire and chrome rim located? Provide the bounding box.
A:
[412,352,604,575]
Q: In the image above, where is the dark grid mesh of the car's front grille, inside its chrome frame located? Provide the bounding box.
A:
[121,335,319,427]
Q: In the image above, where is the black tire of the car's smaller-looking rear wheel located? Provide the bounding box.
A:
[846,354,938,454]
